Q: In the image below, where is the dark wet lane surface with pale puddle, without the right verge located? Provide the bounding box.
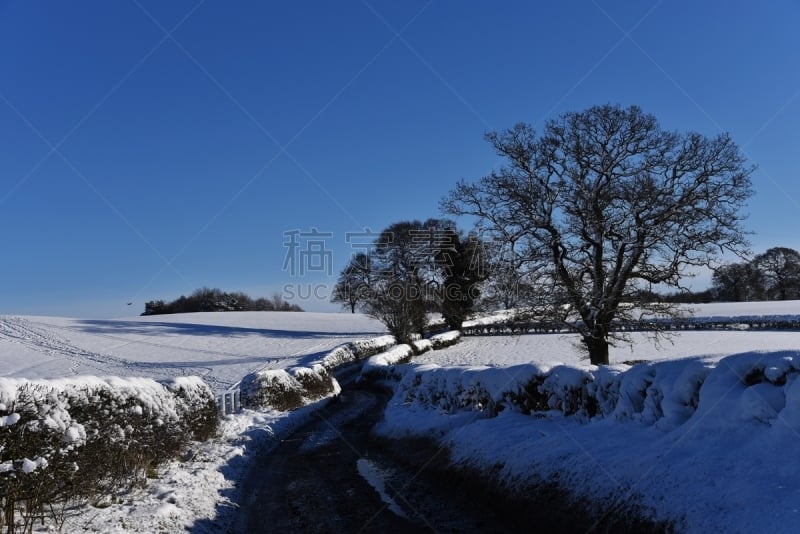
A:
[236,386,524,532]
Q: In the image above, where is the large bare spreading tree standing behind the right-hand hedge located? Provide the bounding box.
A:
[442,105,753,364]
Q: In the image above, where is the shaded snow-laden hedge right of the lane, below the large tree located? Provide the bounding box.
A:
[396,352,800,430]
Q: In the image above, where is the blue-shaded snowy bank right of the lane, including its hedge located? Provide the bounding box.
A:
[378,351,800,532]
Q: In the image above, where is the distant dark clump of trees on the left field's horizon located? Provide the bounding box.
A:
[142,287,303,315]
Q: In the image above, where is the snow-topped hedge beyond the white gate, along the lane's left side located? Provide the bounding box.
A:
[239,336,397,411]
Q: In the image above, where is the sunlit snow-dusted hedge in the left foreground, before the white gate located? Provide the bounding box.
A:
[0,377,218,530]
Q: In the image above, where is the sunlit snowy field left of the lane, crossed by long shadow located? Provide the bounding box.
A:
[0,312,385,392]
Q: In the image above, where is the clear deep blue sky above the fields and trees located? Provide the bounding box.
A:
[0,0,800,317]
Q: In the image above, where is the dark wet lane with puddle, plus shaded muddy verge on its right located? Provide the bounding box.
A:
[234,372,663,533]
